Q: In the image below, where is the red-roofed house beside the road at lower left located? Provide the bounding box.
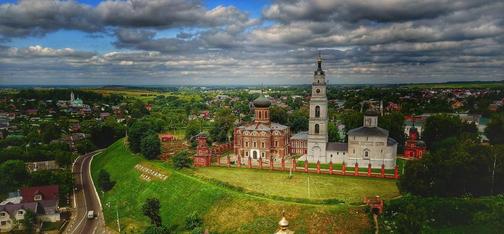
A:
[20,185,61,222]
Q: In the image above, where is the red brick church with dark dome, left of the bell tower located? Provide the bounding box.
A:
[233,95,290,162]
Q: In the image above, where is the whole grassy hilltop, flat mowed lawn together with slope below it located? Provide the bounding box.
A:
[92,140,397,233]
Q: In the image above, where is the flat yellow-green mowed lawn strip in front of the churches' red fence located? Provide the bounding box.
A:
[195,167,399,203]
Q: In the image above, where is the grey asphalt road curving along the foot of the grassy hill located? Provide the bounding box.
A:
[65,151,105,234]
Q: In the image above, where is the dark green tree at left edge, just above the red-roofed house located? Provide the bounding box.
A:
[0,160,30,194]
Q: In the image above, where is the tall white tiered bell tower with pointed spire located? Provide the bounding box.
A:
[307,54,328,163]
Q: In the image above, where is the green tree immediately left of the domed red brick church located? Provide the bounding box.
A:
[210,108,236,142]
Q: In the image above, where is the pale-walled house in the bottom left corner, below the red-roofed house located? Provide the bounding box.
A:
[0,202,38,232]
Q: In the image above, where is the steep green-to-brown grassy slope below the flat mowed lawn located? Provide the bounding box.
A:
[92,140,378,233]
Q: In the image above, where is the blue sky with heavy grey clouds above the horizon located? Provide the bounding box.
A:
[0,0,504,85]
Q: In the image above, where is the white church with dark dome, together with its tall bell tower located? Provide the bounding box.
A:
[301,56,397,169]
